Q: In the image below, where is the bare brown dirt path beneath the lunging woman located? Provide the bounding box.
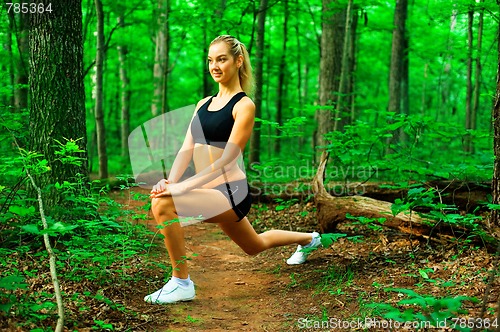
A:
[137,219,310,331]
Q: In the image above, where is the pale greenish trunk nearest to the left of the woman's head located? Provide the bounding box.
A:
[151,0,170,116]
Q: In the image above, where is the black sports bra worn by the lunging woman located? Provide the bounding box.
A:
[191,92,246,148]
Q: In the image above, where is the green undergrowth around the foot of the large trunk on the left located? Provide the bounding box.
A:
[0,141,161,330]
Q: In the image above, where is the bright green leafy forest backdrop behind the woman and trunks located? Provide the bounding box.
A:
[0,1,497,185]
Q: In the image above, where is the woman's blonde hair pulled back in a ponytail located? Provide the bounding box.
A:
[210,35,254,95]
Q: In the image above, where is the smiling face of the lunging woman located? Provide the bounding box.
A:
[208,42,242,83]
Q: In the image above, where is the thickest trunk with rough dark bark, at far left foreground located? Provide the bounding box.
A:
[29,0,88,213]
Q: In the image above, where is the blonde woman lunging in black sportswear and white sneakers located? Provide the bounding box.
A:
[144,35,321,303]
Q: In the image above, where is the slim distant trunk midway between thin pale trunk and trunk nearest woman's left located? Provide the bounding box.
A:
[117,14,130,159]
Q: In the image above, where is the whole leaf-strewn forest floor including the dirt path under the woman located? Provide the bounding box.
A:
[3,188,500,332]
